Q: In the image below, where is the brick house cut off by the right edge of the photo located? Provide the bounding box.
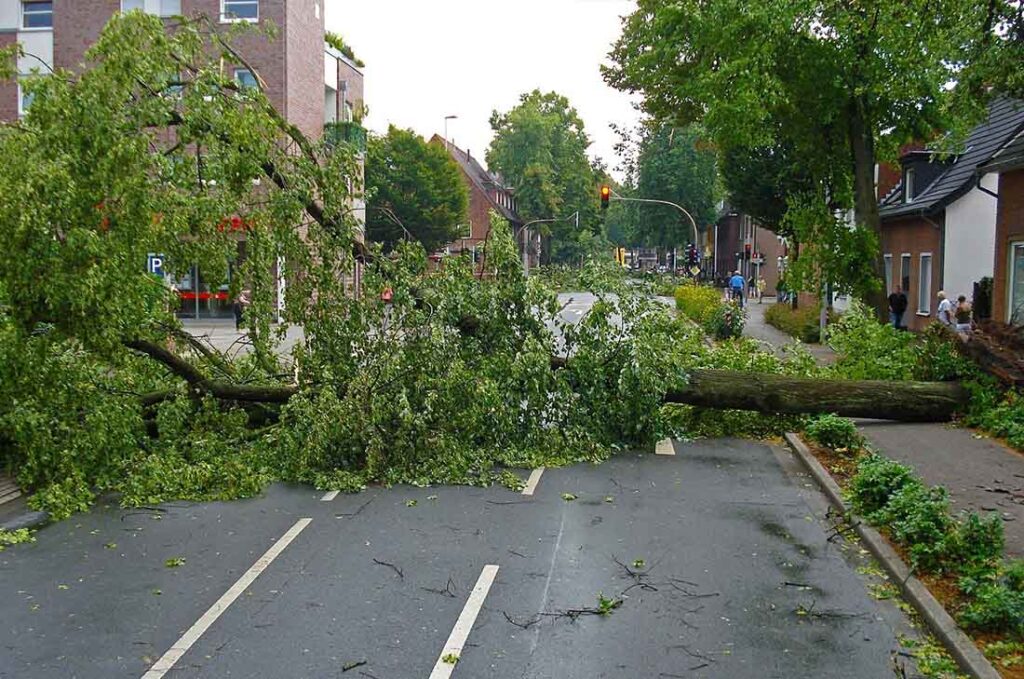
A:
[978,130,1024,326]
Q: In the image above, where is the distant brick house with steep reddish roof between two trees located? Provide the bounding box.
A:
[430,134,528,267]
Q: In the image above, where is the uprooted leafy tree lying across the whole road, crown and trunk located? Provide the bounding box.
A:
[0,12,963,515]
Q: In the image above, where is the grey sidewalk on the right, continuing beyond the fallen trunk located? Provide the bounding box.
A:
[743,298,1024,558]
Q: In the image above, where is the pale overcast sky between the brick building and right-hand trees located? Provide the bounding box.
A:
[326,0,638,178]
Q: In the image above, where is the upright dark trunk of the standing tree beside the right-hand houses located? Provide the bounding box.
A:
[849,95,888,321]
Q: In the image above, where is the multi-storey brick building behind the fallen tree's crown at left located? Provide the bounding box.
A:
[0,0,366,316]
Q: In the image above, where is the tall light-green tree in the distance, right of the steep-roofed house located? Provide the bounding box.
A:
[486,90,600,261]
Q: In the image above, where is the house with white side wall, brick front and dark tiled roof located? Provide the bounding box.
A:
[879,98,1024,330]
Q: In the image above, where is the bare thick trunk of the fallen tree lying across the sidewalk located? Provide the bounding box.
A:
[665,370,968,422]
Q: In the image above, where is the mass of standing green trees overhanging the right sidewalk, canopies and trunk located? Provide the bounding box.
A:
[604,0,1024,301]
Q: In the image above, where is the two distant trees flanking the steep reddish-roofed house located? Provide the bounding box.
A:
[366,90,606,261]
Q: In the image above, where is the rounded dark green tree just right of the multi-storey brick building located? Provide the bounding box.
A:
[367,125,469,252]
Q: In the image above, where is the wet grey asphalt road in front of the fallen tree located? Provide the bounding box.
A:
[0,440,925,679]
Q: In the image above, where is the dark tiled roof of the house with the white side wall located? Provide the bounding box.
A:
[879,97,1024,219]
